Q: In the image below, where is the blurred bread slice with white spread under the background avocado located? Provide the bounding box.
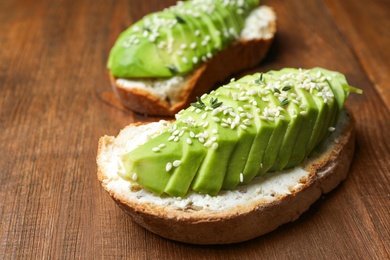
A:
[110,6,276,116]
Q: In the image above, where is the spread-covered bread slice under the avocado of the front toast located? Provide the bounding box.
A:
[97,111,355,244]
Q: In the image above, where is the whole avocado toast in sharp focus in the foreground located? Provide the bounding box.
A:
[97,68,361,244]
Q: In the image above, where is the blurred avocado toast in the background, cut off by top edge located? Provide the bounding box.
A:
[107,0,276,116]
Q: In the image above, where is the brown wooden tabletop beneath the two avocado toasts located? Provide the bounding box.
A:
[0,0,390,259]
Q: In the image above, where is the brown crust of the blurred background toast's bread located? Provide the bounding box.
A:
[109,9,276,116]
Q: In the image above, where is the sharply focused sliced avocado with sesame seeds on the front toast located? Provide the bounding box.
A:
[121,68,358,197]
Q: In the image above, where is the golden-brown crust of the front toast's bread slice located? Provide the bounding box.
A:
[97,110,355,244]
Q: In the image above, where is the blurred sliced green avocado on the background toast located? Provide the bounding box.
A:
[107,0,259,78]
